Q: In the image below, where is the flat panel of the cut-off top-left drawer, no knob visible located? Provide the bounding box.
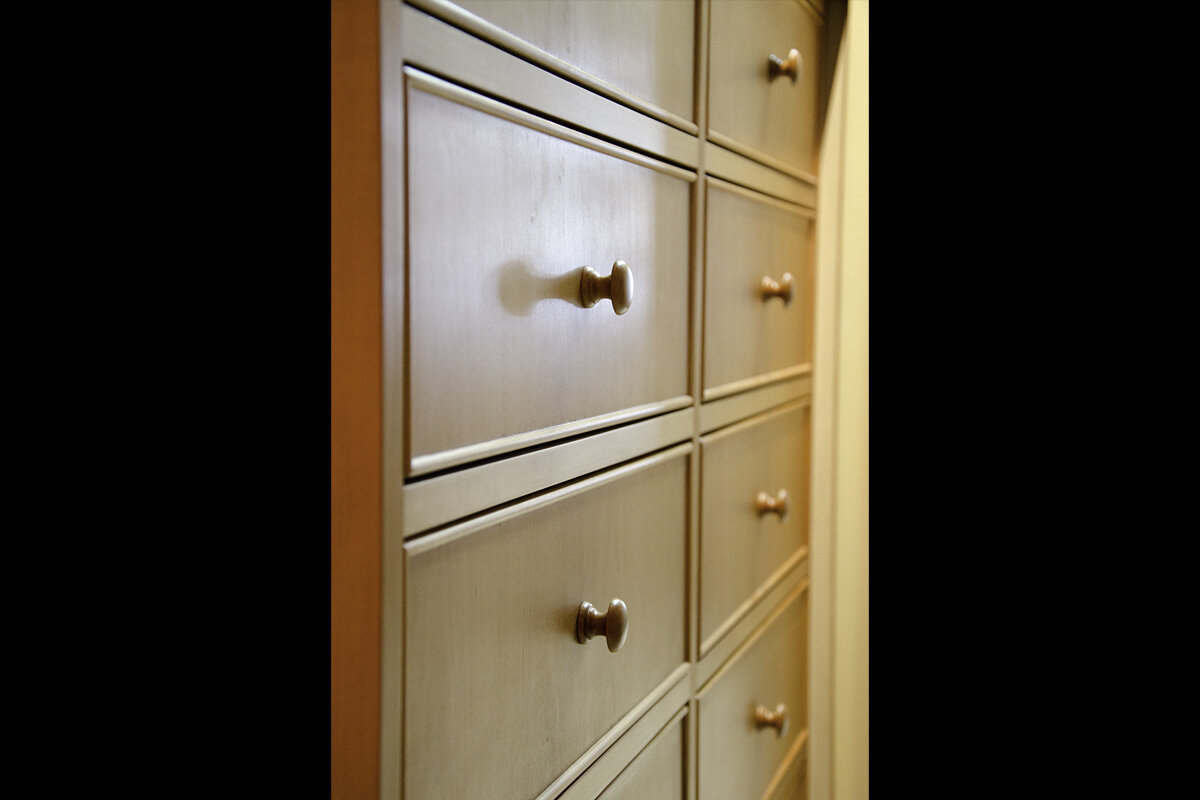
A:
[456,0,696,121]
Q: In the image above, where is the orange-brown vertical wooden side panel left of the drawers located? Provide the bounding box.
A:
[330,0,383,800]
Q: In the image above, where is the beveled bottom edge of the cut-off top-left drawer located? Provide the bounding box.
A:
[403,0,700,136]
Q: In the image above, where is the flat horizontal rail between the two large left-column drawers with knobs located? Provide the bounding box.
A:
[403,407,696,537]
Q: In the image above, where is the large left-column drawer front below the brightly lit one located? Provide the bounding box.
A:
[404,453,689,800]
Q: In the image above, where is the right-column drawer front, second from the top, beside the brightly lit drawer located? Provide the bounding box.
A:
[704,180,812,399]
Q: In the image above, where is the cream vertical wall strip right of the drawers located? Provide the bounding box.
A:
[809,0,870,800]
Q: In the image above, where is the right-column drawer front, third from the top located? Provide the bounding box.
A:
[700,404,809,652]
